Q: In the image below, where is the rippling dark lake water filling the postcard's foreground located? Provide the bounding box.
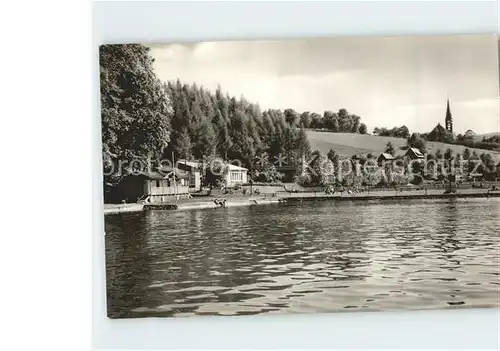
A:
[105,198,500,318]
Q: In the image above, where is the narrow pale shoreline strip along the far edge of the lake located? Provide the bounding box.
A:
[104,189,500,215]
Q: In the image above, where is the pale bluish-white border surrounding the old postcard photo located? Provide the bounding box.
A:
[92,1,500,349]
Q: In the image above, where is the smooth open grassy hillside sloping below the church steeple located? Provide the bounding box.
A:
[307,130,500,163]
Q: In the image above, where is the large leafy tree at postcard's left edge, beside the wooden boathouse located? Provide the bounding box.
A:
[99,44,173,191]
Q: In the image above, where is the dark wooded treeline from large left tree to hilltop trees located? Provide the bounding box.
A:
[100,44,366,185]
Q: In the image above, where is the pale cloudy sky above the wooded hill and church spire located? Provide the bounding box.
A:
[150,35,500,134]
